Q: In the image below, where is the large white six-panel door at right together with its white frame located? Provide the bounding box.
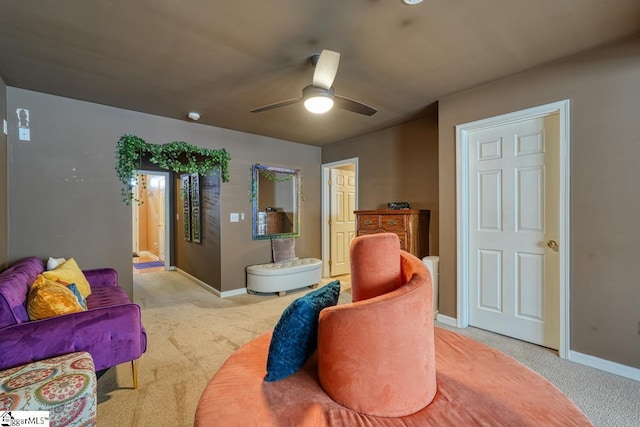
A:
[456,101,570,358]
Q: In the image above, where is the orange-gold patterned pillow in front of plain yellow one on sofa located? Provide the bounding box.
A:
[27,274,84,320]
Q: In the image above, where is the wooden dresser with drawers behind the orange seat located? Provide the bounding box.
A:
[354,209,431,259]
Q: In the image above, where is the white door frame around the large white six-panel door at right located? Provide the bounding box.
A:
[456,100,571,359]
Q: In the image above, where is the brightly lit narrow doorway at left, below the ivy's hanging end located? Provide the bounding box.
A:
[131,170,171,272]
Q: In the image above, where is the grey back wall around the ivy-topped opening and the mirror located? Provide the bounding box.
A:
[5,87,320,295]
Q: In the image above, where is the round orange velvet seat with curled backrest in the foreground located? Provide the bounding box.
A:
[195,234,591,427]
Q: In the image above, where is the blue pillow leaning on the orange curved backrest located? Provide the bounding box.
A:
[264,280,340,381]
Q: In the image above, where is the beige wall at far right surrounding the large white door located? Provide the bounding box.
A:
[439,39,640,367]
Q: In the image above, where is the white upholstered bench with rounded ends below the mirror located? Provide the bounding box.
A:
[247,258,322,295]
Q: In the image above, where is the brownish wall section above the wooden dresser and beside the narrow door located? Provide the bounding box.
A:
[322,114,440,255]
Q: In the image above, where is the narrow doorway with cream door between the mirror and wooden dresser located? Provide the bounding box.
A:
[322,158,358,277]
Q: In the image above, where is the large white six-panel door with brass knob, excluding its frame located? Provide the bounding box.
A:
[468,113,563,349]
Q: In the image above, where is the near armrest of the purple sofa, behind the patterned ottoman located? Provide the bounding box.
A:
[0,304,147,370]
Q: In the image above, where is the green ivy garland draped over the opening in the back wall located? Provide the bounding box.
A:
[116,134,231,205]
